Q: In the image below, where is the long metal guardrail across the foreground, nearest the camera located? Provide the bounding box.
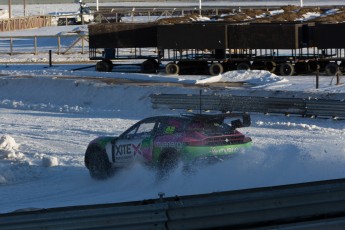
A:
[0,179,345,230]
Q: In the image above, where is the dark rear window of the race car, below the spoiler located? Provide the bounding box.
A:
[187,120,234,136]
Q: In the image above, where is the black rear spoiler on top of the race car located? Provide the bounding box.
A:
[182,113,251,128]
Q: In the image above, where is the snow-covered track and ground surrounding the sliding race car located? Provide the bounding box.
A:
[0,1,345,213]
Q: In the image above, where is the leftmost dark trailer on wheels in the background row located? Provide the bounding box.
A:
[89,23,158,72]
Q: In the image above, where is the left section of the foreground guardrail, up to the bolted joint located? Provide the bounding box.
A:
[0,203,168,230]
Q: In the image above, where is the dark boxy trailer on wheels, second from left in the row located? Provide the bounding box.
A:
[157,22,228,75]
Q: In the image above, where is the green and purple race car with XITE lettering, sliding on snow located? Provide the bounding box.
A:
[85,113,251,179]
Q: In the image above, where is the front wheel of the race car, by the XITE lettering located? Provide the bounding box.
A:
[85,145,112,180]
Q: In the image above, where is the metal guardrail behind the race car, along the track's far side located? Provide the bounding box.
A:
[151,94,345,118]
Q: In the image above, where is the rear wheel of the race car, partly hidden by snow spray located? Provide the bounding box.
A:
[158,148,179,176]
